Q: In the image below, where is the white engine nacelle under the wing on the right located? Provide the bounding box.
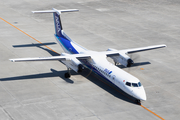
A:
[107,48,134,67]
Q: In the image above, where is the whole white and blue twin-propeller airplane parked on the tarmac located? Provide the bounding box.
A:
[10,8,166,104]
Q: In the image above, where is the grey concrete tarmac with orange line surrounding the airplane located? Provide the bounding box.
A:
[0,0,180,120]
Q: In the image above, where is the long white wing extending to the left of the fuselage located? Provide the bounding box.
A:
[9,54,91,62]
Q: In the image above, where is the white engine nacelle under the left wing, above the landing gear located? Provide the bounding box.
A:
[61,53,84,73]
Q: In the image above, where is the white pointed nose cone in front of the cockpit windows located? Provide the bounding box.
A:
[133,86,146,101]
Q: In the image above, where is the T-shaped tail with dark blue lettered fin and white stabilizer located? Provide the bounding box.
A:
[32,8,79,40]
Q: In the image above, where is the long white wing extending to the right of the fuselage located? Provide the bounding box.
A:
[105,44,166,57]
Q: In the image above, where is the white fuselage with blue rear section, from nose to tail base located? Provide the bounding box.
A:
[55,37,146,101]
